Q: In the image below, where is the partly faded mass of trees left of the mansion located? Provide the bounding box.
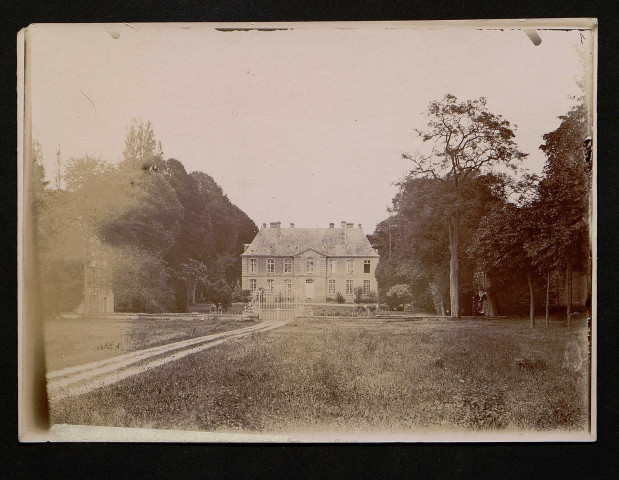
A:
[33,120,258,314]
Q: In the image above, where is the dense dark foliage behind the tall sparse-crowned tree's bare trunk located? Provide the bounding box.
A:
[372,174,506,315]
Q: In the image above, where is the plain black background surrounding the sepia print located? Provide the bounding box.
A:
[0,0,619,479]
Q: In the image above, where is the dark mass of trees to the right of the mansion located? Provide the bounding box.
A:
[370,95,592,324]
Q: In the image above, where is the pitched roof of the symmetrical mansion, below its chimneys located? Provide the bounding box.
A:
[243,227,378,257]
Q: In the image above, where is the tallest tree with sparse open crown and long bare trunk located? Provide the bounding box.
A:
[402,94,526,317]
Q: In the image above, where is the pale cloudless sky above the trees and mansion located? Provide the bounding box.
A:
[28,24,592,233]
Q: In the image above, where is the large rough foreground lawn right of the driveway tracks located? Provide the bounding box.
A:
[51,319,589,433]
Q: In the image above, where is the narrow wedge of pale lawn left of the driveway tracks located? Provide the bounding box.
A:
[44,315,255,372]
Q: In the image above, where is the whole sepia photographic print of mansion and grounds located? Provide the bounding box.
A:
[17,18,597,442]
